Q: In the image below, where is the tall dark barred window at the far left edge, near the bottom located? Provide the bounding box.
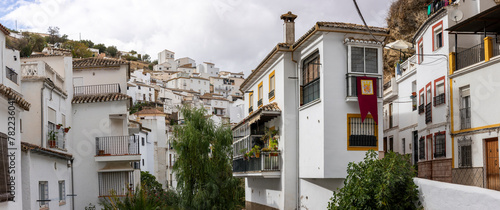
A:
[0,133,14,202]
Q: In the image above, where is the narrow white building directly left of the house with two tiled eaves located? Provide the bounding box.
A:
[21,55,74,209]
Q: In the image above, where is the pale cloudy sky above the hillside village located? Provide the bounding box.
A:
[0,0,392,75]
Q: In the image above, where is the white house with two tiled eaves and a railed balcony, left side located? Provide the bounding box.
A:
[68,58,141,209]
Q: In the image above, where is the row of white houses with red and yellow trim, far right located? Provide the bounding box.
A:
[383,0,500,190]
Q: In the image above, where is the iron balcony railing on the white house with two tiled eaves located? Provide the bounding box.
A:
[95,136,140,156]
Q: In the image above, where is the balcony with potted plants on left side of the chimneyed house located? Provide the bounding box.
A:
[233,151,281,178]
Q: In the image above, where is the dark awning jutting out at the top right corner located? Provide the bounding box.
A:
[446,5,500,34]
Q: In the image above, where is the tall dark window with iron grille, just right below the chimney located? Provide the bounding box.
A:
[300,52,321,105]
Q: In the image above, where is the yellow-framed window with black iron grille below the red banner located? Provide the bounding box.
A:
[347,114,378,150]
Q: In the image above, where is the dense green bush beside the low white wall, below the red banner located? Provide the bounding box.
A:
[328,150,420,209]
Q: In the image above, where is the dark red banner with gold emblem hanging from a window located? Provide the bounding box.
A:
[356,77,378,125]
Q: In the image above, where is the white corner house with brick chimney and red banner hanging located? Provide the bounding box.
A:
[233,12,388,209]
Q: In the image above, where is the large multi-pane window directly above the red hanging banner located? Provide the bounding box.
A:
[350,46,378,74]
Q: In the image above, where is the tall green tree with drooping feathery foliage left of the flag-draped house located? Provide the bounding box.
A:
[173,106,243,209]
